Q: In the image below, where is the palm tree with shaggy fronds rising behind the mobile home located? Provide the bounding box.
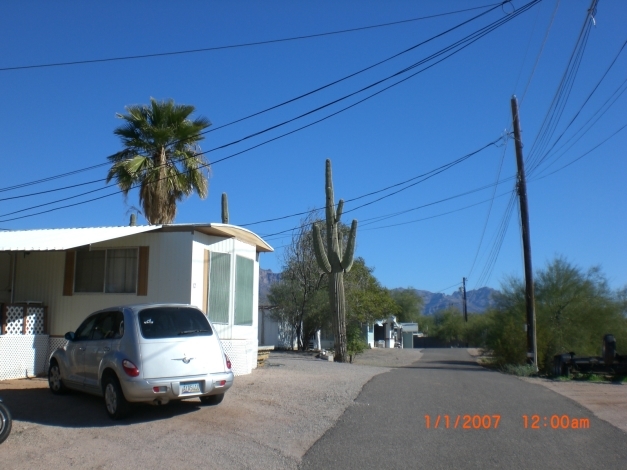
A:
[107,98,211,224]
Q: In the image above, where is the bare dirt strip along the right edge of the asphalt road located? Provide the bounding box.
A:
[468,348,627,432]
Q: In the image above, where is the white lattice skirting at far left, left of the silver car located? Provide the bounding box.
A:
[0,335,49,380]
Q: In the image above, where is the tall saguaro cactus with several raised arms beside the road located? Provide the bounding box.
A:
[313,159,357,362]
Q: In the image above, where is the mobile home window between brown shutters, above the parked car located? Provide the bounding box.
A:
[74,248,138,294]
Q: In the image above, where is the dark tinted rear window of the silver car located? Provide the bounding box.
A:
[139,307,213,339]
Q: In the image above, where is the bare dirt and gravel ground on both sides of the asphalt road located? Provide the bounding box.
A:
[0,349,627,470]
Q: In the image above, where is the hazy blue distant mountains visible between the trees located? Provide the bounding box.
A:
[259,269,498,315]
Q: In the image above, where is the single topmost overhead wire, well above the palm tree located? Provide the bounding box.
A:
[0,0,502,72]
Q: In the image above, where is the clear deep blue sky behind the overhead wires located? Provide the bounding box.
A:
[0,0,627,292]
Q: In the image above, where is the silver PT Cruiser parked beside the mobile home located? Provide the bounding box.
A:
[48,304,233,419]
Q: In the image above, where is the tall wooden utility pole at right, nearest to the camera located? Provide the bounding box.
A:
[511,95,538,370]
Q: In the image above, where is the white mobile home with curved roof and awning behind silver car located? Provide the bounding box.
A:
[0,224,272,380]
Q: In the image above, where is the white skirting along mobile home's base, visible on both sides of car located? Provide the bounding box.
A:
[0,335,257,380]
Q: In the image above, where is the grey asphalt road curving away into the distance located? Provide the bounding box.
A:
[301,349,627,470]
